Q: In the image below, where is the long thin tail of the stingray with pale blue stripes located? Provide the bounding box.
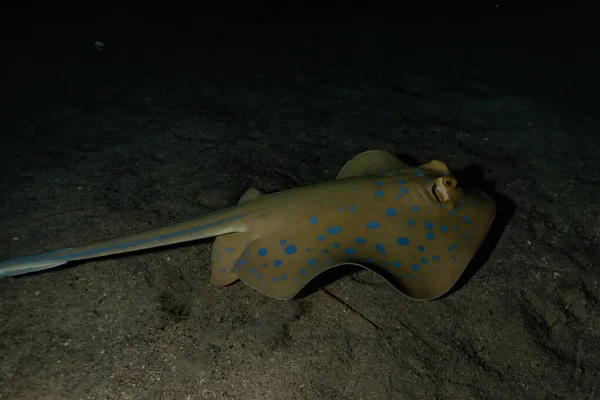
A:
[0,207,248,277]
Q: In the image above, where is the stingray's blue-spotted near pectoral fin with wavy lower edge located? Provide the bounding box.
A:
[230,177,496,300]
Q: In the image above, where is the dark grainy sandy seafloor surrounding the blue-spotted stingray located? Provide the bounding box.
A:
[0,15,600,400]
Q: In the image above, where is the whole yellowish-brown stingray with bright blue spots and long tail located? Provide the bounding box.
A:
[0,150,496,300]
